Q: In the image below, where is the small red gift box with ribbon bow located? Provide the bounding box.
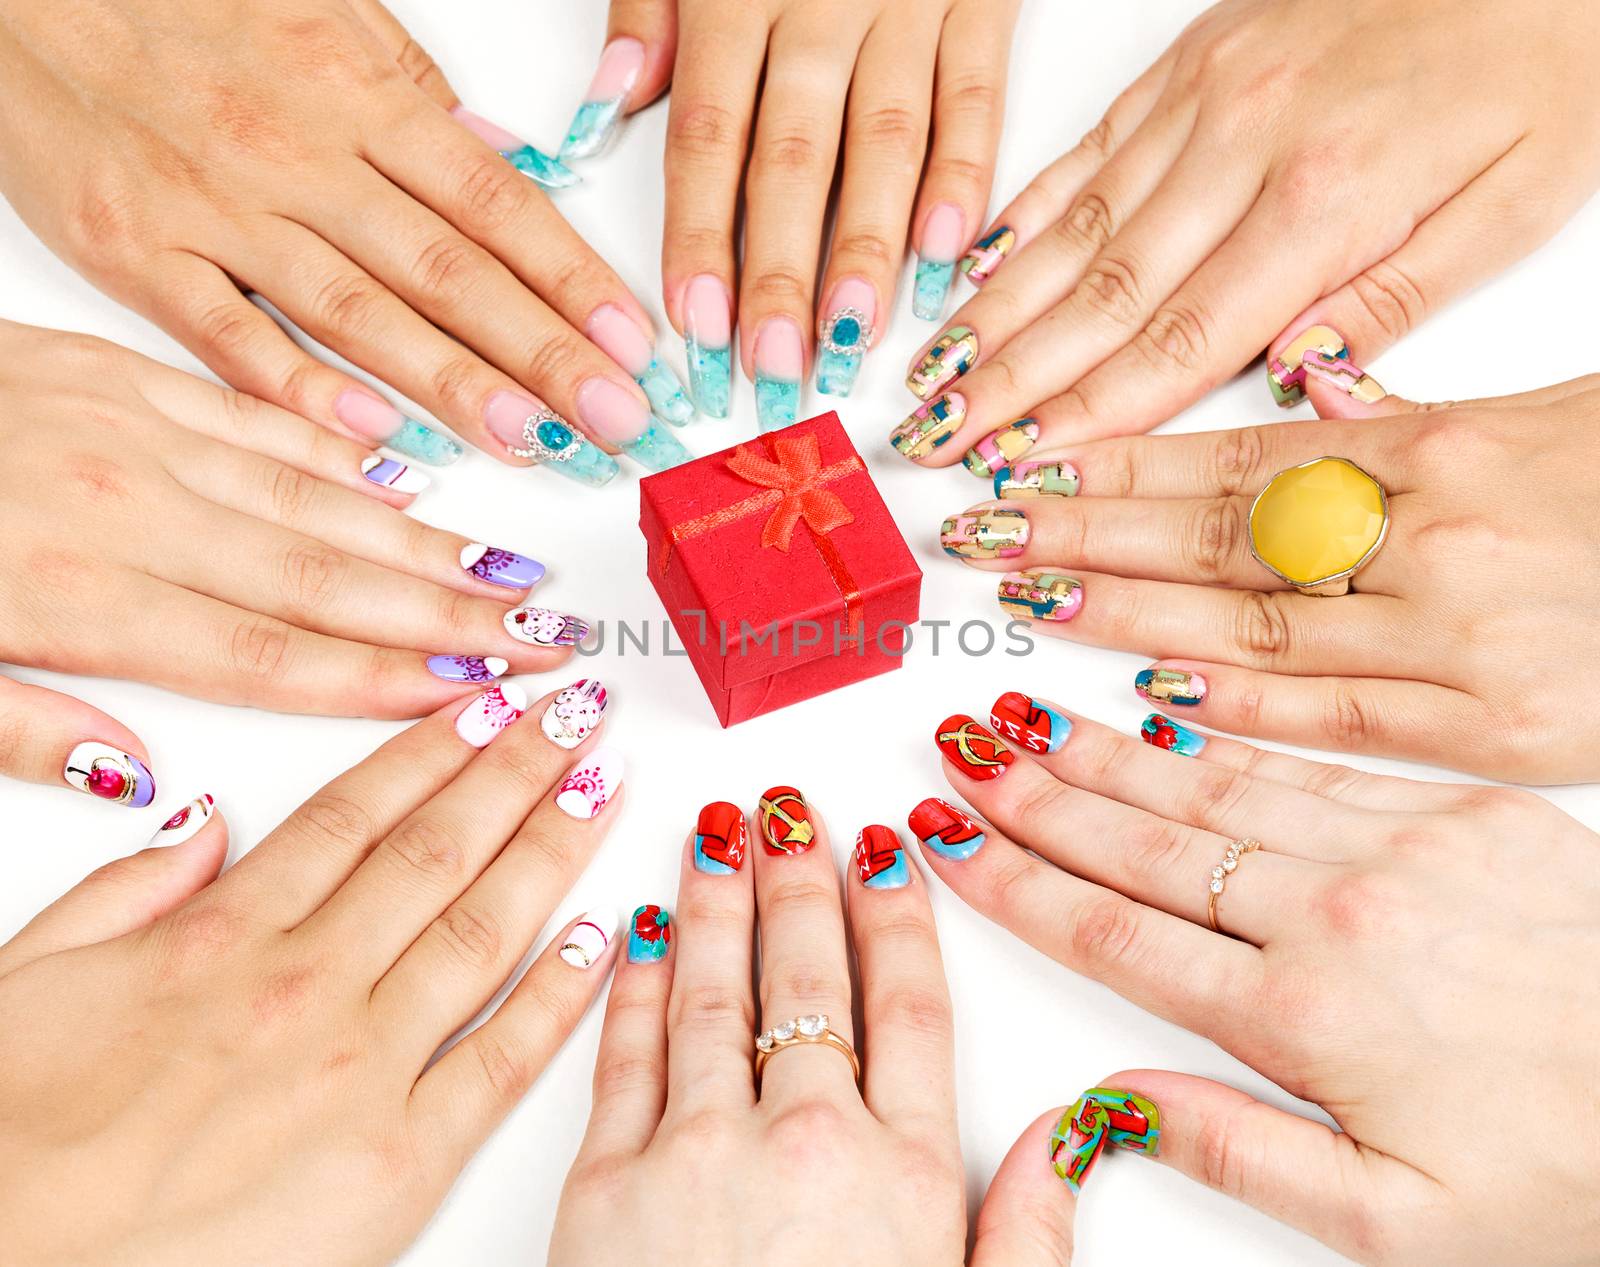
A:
[638,413,922,726]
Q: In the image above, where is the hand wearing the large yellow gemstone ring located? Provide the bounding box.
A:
[946,361,1600,784]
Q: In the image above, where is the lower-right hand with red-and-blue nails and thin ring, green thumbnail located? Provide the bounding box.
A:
[910,693,1600,1267]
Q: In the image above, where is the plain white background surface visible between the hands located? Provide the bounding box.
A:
[0,0,1600,1267]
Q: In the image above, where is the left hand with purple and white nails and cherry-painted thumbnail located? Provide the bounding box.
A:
[0,323,587,806]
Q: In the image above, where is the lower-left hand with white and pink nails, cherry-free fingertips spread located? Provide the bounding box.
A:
[0,688,622,1264]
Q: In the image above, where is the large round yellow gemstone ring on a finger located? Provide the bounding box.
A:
[1250,458,1389,595]
